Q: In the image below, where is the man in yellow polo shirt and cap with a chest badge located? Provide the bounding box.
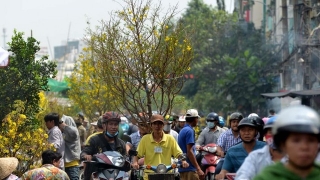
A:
[132,114,189,180]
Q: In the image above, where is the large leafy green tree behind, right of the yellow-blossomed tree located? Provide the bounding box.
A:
[182,0,279,112]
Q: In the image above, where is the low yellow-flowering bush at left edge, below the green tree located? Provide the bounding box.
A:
[0,98,54,175]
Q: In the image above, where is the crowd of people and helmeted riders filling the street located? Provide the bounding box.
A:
[0,105,320,180]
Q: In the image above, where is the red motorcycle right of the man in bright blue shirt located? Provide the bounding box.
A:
[198,143,220,180]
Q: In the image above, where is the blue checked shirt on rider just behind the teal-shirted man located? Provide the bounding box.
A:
[218,129,242,152]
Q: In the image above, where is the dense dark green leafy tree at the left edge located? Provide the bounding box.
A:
[0,31,56,119]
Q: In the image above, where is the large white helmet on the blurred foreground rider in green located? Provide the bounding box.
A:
[272,105,320,135]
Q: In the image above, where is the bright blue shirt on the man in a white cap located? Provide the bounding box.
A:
[178,124,196,172]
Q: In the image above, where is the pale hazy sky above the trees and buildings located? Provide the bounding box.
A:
[0,0,233,58]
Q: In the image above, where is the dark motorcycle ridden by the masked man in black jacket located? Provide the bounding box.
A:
[84,151,130,180]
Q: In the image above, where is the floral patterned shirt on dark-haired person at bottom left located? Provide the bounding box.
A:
[21,164,69,180]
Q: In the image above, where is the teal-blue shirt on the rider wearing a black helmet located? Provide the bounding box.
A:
[222,141,266,173]
